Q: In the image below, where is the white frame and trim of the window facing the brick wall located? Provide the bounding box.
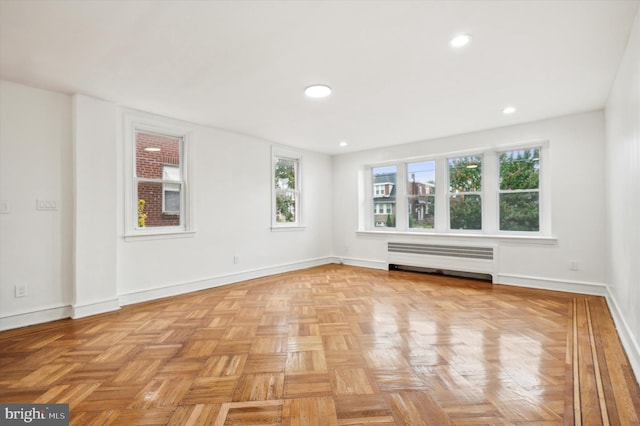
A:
[122,111,195,241]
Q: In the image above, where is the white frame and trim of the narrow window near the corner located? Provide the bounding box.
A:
[269,146,305,231]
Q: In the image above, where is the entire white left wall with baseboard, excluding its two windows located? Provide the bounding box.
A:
[0,81,332,330]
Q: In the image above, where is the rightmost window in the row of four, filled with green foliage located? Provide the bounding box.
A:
[498,148,540,232]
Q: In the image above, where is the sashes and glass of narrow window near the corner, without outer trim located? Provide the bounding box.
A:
[273,156,300,225]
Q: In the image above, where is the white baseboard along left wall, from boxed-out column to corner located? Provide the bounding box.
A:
[119,257,338,306]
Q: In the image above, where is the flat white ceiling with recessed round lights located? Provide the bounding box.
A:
[0,0,640,154]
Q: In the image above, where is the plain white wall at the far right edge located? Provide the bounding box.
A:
[605,9,640,377]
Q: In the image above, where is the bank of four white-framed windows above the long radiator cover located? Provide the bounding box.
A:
[358,141,551,238]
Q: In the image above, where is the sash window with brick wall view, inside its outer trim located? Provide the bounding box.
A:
[134,130,186,229]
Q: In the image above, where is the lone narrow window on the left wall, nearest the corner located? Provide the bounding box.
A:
[272,150,302,228]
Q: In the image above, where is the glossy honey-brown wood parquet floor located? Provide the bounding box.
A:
[0,265,640,426]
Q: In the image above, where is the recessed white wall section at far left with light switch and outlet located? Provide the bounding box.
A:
[0,81,73,329]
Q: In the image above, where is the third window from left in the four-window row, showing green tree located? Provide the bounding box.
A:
[448,155,482,230]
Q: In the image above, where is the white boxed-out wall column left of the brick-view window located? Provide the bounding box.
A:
[72,95,119,318]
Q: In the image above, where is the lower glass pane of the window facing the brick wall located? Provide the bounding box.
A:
[138,182,181,228]
